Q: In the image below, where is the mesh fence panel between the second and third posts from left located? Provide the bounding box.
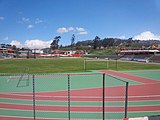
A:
[70,74,103,120]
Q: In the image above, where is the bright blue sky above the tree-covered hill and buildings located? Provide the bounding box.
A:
[0,0,160,48]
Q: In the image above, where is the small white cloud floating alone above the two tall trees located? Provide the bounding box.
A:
[57,27,88,35]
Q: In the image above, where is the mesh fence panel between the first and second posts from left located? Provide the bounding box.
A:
[35,74,68,119]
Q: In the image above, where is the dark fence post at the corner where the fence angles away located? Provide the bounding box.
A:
[102,73,105,120]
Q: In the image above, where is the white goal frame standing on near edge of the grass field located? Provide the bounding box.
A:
[83,58,109,71]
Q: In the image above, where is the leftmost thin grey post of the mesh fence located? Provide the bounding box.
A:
[32,75,36,120]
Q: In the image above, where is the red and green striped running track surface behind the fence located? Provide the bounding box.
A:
[0,70,160,120]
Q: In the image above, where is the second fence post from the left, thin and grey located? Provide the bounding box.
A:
[68,74,71,120]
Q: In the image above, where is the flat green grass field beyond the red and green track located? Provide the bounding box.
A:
[0,58,160,74]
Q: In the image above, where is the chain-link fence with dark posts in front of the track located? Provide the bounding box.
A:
[0,73,128,120]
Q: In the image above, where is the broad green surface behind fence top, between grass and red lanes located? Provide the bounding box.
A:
[0,74,139,92]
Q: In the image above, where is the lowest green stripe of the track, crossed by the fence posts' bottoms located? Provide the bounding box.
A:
[0,110,159,120]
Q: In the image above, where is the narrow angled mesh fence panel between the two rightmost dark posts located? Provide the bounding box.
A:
[105,75,127,120]
